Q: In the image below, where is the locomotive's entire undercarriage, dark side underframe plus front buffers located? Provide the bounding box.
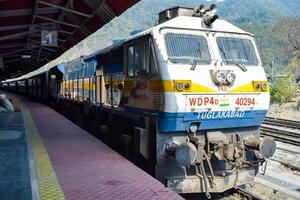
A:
[54,101,275,194]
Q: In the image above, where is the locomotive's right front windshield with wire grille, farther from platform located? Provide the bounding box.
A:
[217,37,257,65]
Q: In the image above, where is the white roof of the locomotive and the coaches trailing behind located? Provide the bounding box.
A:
[3,16,253,83]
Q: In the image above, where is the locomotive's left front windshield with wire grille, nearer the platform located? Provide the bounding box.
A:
[165,33,211,64]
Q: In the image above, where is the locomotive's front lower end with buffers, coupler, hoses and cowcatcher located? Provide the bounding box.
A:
[156,127,275,196]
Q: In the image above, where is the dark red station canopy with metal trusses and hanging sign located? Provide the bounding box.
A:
[0,0,139,79]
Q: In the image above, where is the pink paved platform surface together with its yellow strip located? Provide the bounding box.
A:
[0,94,183,200]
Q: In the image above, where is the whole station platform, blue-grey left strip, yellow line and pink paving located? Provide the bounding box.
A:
[0,94,183,200]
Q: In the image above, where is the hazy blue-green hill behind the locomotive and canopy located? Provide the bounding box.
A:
[58,0,300,72]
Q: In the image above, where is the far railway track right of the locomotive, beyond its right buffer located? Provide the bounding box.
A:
[260,117,300,146]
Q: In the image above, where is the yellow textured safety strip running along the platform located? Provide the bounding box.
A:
[21,105,65,200]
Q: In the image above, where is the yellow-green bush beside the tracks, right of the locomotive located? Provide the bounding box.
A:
[271,77,296,104]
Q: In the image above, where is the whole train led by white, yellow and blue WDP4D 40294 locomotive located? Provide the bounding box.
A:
[2,5,276,196]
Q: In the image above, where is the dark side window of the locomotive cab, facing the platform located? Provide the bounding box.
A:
[127,40,157,78]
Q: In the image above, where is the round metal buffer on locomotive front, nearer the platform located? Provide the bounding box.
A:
[175,142,197,166]
